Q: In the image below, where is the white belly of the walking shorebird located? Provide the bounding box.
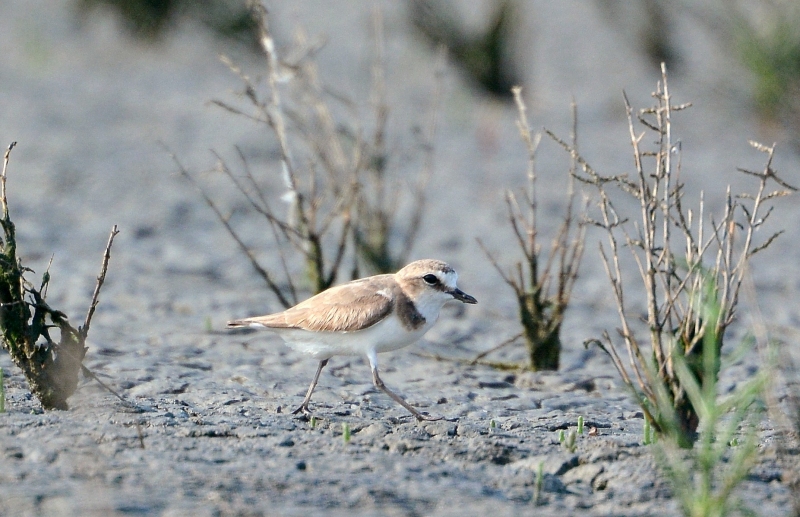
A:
[270,316,436,360]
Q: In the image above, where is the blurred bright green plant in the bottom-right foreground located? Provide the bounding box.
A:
[655,278,768,517]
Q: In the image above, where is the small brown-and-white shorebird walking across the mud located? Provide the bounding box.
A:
[228,259,478,420]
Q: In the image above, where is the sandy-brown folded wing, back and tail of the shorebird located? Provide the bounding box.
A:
[228,275,394,332]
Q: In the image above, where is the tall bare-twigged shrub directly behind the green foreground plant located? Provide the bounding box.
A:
[549,65,795,446]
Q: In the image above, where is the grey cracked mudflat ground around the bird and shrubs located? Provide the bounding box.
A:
[0,1,800,516]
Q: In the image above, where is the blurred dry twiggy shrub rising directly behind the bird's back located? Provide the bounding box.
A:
[175,1,438,307]
